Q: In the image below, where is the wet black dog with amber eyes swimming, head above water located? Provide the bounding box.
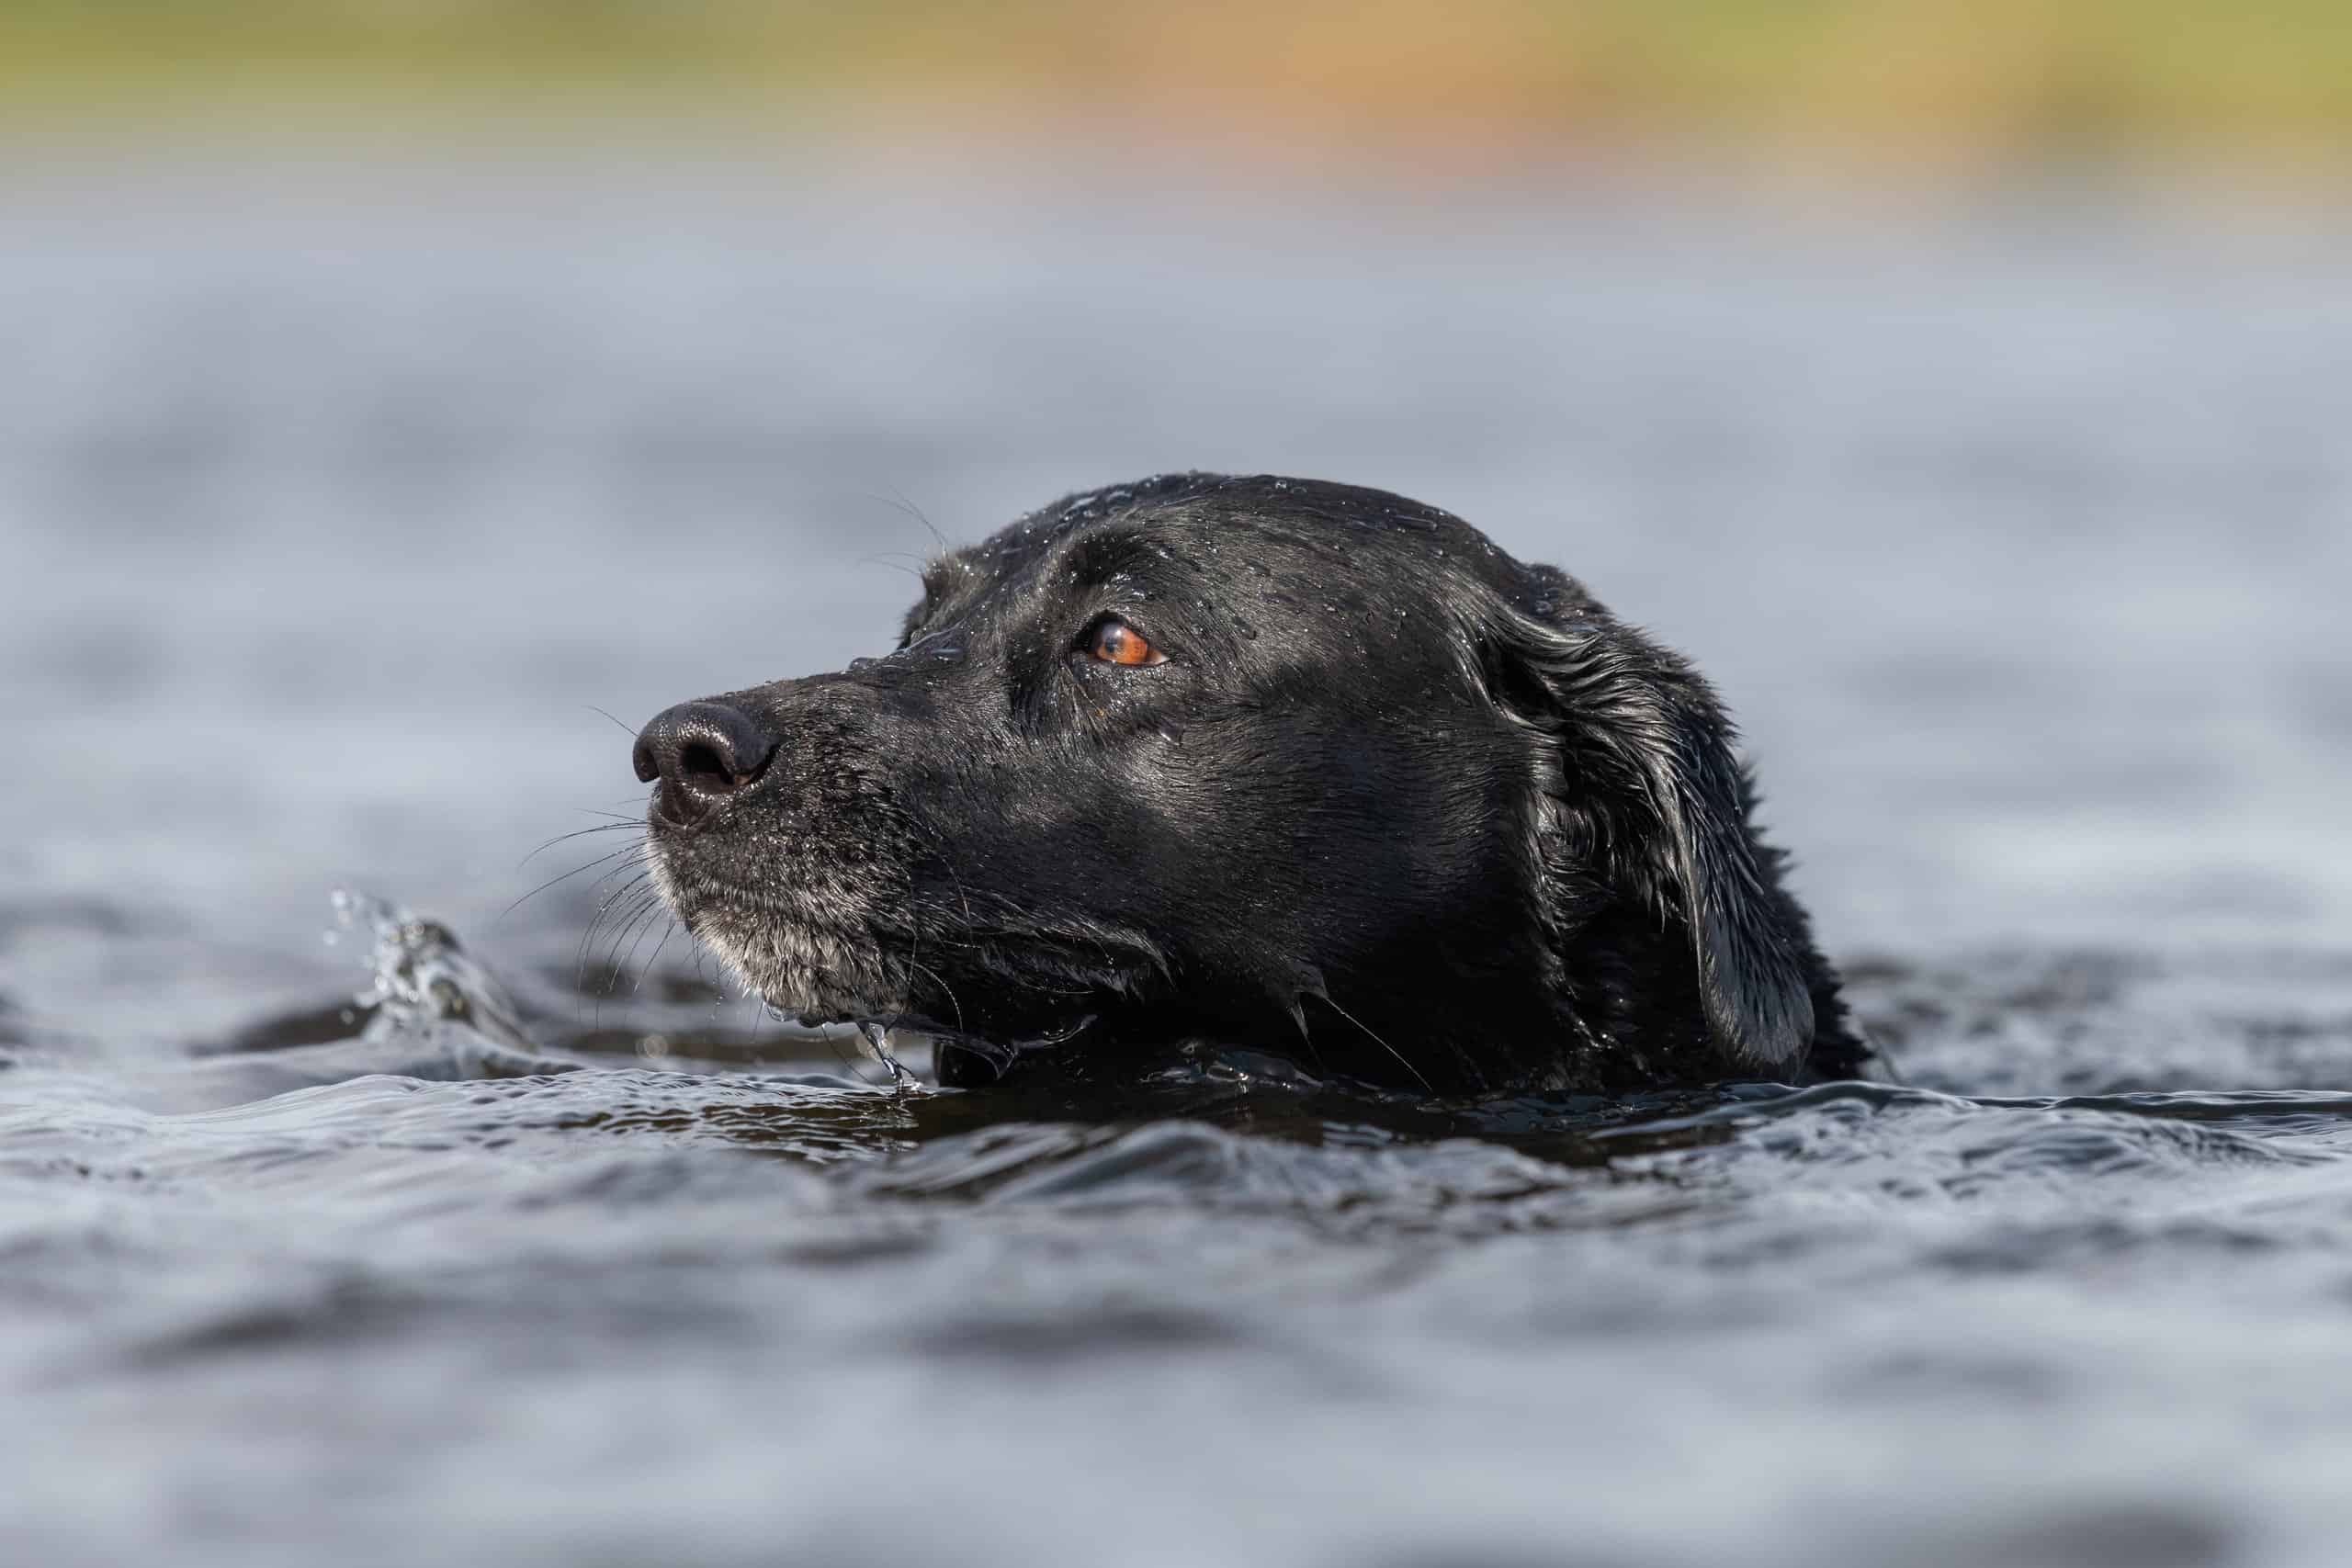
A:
[635,475,1865,1093]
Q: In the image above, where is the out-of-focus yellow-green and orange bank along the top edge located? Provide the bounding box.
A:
[14,0,2352,174]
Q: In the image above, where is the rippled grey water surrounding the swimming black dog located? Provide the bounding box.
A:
[0,152,2352,1568]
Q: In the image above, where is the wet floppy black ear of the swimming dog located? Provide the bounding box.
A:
[1479,582,1814,1069]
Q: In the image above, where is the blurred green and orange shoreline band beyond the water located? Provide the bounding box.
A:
[0,0,2352,211]
